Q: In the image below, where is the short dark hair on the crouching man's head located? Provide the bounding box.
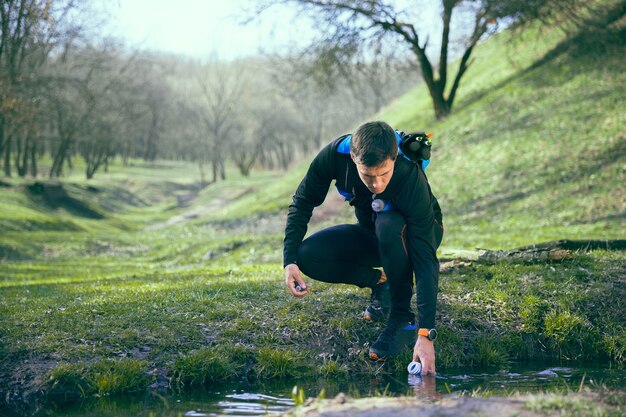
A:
[350,122,398,167]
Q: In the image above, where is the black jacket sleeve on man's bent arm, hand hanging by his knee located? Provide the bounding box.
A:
[283,143,335,266]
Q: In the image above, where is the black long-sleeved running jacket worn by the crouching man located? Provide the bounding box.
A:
[283,135,443,329]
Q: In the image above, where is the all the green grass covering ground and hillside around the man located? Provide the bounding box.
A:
[0,13,626,407]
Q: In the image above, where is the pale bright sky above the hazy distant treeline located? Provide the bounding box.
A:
[103,0,313,60]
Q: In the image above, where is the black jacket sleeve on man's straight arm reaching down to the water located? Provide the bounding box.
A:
[398,170,439,329]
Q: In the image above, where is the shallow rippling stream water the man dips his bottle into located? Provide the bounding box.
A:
[38,366,626,417]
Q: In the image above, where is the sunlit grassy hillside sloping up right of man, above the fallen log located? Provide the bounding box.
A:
[379,29,626,248]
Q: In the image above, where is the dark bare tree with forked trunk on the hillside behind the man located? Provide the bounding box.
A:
[259,0,596,118]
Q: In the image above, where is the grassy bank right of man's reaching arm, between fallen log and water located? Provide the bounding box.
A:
[439,251,626,366]
